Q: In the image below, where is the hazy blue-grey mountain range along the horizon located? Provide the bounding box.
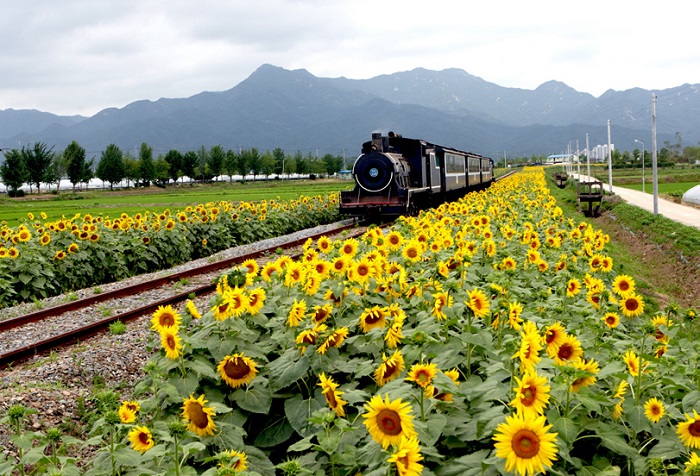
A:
[0,65,700,158]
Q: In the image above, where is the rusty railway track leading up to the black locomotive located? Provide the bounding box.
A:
[0,222,374,369]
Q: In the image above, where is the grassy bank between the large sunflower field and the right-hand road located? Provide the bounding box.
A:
[547,170,700,313]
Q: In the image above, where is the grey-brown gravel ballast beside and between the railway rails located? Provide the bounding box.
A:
[0,221,358,462]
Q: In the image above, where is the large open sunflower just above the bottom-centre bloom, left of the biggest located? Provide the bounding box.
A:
[362,395,418,449]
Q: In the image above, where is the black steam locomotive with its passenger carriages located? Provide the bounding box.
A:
[340,132,493,218]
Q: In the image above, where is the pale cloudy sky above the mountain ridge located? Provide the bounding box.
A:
[0,0,700,116]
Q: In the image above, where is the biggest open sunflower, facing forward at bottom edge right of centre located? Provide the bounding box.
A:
[493,413,557,476]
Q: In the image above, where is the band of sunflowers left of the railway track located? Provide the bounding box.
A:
[0,194,338,308]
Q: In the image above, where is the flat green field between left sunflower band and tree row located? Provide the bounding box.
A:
[0,179,354,226]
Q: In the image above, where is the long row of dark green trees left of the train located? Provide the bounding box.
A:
[0,141,344,193]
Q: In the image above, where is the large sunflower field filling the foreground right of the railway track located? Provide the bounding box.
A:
[5,168,700,476]
